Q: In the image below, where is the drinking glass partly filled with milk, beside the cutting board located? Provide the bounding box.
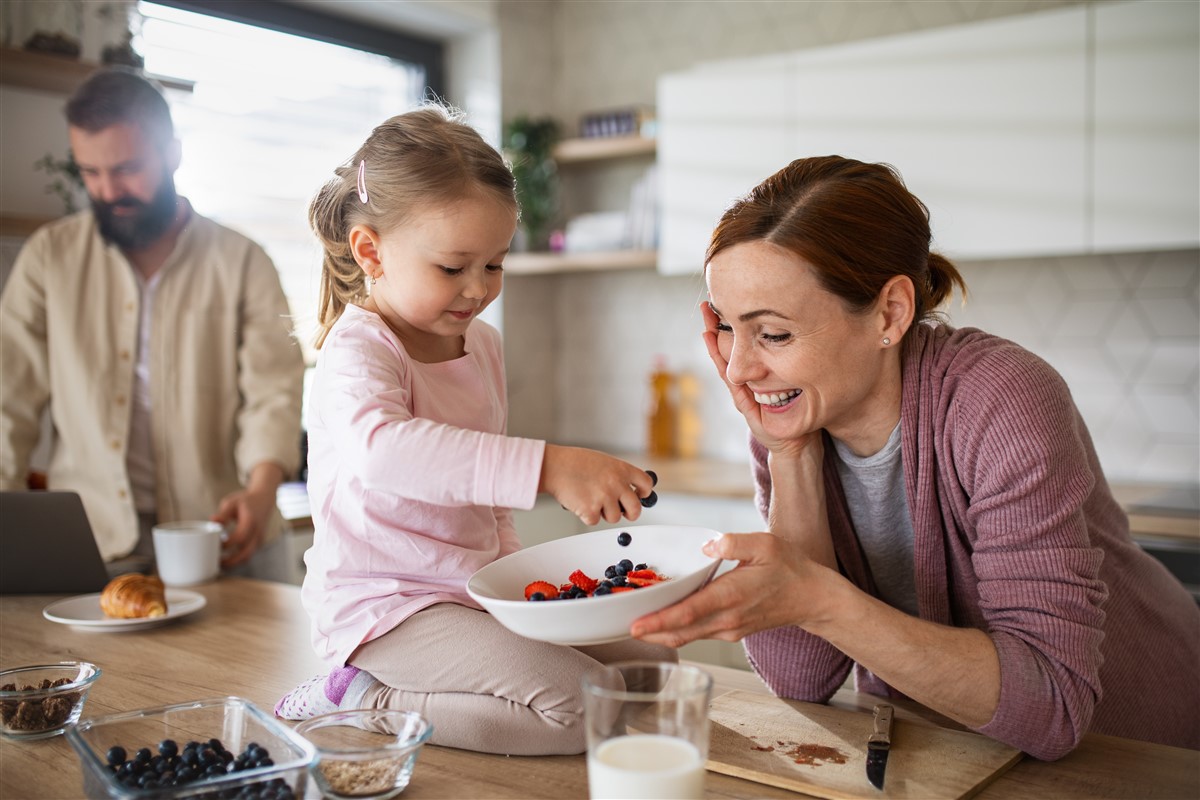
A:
[583,661,713,800]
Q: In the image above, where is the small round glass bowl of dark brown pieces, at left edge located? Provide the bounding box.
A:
[0,661,101,739]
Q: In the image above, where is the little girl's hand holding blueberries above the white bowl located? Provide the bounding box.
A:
[538,444,654,525]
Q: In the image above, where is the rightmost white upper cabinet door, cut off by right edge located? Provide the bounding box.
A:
[1092,0,1200,251]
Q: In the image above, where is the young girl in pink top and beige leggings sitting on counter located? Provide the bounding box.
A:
[275,107,676,754]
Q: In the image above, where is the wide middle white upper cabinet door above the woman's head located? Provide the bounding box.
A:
[780,7,1087,258]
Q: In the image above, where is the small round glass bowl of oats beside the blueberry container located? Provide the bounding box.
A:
[295,709,433,800]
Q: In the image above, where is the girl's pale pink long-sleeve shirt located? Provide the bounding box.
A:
[301,306,545,666]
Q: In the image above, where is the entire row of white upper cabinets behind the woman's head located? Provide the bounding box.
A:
[659,1,1200,272]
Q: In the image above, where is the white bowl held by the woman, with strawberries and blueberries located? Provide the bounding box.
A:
[467,525,721,645]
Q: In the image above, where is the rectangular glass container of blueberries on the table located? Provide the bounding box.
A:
[67,697,316,800]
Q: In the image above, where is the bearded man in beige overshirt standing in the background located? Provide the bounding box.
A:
[0,67,304,572]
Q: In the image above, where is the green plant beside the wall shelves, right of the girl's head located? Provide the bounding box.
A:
[504,116,558,249]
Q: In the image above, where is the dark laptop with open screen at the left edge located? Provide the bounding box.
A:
[0,492,108,595]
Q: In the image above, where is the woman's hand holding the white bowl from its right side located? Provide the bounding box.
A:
[631,534,844,648]
